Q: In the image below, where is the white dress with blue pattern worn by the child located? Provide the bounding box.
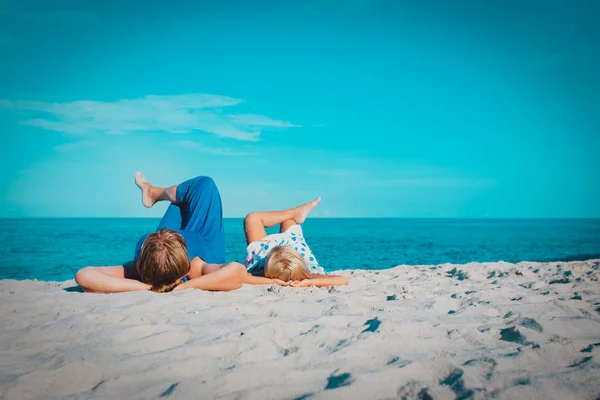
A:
[244,225,325,275]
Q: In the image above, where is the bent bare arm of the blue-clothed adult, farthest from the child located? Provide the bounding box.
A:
[75,265,150,293]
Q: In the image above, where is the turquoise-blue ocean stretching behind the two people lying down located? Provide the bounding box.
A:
[0,218,600,281]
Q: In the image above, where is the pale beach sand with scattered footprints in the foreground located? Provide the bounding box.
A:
[0,260,600,400]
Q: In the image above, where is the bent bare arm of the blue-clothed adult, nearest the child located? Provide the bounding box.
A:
[174,262,247,291]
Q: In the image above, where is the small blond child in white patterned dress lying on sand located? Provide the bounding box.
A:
[244,198,348,287]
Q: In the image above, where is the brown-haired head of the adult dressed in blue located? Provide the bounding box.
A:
[137,229,190,293]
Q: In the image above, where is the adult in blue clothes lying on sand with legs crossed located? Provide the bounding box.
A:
[75,172,247,293]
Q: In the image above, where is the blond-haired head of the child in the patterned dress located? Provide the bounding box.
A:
[265,246,312,282]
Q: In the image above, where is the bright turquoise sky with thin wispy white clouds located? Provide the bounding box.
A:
[0,0,600,218]
